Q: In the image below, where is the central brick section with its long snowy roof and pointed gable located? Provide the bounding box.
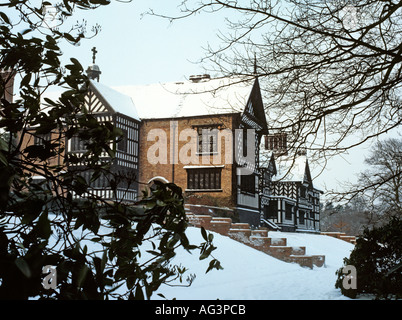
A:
[113,75,267,225]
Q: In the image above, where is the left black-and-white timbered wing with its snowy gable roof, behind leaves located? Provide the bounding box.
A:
[66,78,141,202]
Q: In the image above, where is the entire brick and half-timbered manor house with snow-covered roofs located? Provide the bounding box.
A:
[22,47,320,232]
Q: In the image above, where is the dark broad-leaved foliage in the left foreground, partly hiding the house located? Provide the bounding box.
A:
[0,0,221,299]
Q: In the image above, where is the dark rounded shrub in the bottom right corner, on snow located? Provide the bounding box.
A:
[335,217,402,299]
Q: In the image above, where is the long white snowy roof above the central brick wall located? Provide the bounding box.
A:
[111,77,254,119]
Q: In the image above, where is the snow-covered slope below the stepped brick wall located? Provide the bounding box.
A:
[152,227,354,300]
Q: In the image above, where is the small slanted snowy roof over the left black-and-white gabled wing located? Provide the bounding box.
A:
[90,80,140,120]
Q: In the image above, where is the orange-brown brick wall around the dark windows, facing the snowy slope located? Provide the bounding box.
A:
[140,114,239,207]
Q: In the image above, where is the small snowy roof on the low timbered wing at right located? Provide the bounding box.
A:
[273,155,308,182]
